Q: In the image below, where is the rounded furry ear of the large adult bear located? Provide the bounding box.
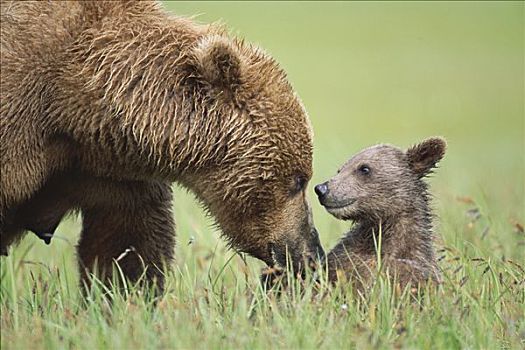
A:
[194,35,242,92]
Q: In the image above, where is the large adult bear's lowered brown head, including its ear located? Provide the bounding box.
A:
[181,34,323,268]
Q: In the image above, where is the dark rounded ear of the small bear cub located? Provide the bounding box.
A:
[406,137,447,178]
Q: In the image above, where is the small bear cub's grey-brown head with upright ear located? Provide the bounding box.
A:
[315,138,446,221]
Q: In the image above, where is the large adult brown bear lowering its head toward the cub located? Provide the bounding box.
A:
[0,1,322,288]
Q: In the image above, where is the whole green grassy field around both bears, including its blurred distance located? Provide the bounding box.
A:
[0,2,525,349]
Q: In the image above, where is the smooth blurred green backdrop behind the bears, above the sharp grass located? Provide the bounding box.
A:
[9,1,525,267]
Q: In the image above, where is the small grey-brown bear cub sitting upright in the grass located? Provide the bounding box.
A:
[315,138,446,290]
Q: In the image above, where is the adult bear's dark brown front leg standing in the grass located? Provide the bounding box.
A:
[78,181,175,289]
